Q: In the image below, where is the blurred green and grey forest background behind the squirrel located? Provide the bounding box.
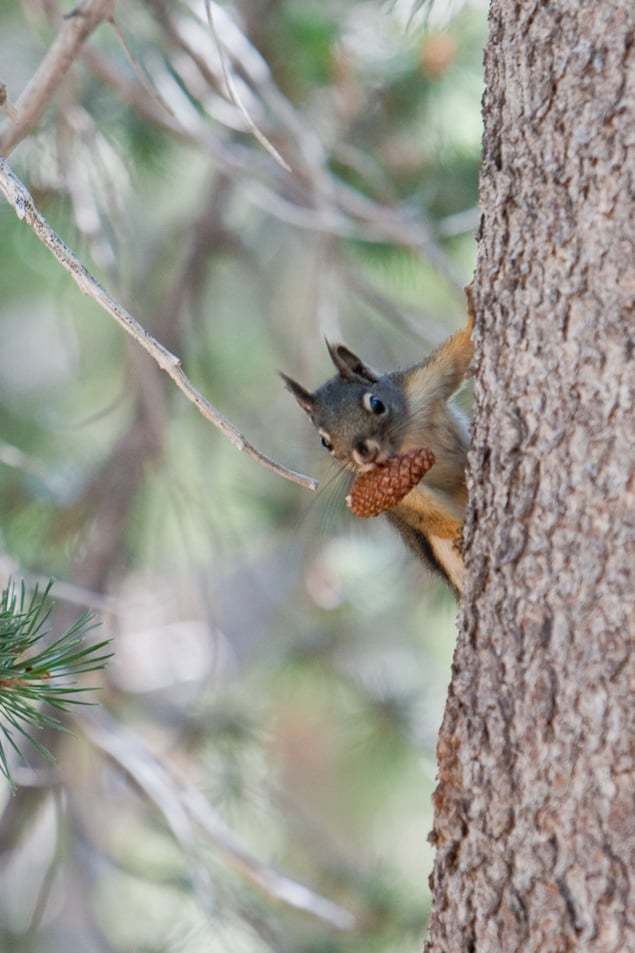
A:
[0,0,486,953]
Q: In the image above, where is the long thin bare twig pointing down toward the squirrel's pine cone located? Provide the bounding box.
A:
[0,158,318,490]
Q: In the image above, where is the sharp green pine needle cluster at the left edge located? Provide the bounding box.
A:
[0,582,112,781]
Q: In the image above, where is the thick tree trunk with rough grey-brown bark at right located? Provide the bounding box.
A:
[426,0,635,953]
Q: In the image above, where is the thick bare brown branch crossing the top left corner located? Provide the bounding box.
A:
[0,0,114,156]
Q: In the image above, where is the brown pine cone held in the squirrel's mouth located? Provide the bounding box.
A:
[346,447,434,517]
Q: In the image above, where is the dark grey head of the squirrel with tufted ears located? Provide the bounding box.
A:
[280,341,407,472]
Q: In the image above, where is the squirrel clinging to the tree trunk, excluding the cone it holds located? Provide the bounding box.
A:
[280,287,474,595]
